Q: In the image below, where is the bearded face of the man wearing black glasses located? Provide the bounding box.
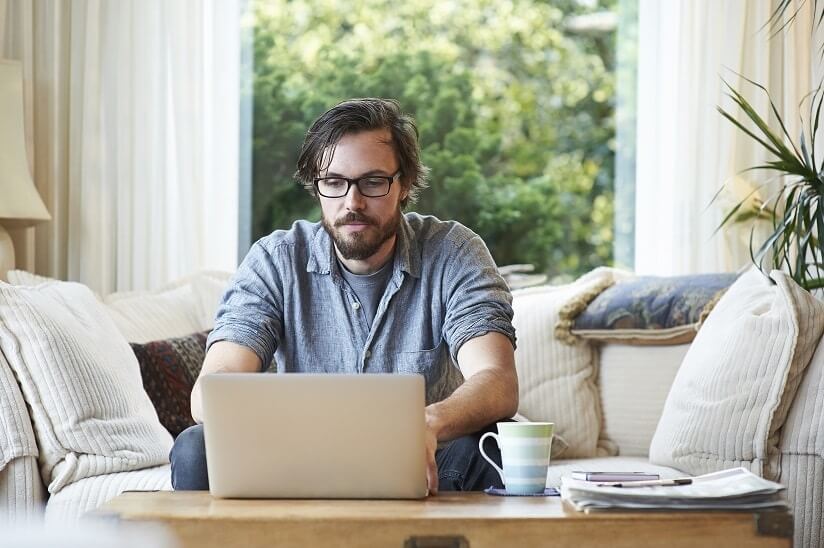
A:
[318,129,406,261]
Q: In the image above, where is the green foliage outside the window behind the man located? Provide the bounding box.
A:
[253,0,614,275]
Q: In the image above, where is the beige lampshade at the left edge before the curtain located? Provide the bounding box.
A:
[0,60,51,228]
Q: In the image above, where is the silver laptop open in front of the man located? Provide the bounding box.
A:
[201,373,427,499]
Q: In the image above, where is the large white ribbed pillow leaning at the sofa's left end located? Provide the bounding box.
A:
[0,282,172,494]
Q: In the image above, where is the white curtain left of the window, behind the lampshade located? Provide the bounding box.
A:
[0,0,240,293]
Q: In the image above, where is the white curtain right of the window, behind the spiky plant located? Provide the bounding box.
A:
[635,0,821,275]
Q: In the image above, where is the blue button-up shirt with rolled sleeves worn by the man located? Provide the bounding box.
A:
[207,213,515,404]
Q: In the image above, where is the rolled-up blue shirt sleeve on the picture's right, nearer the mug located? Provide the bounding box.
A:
[443,235,515,363]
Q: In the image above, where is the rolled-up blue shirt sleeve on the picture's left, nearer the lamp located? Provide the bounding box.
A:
[206,242,283,370]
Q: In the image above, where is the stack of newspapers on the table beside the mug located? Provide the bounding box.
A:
[561,468,787,512]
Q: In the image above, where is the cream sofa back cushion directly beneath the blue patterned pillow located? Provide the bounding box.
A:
[598,344,690,457]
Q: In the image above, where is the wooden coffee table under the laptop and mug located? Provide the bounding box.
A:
[94,491,792,548]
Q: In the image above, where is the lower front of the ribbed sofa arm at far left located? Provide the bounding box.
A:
[0,457,46,520]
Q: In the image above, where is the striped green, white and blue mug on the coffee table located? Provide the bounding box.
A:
[478,422,555,495]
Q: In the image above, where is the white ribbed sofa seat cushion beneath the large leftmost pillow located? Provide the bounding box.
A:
[46,464,172,523]
